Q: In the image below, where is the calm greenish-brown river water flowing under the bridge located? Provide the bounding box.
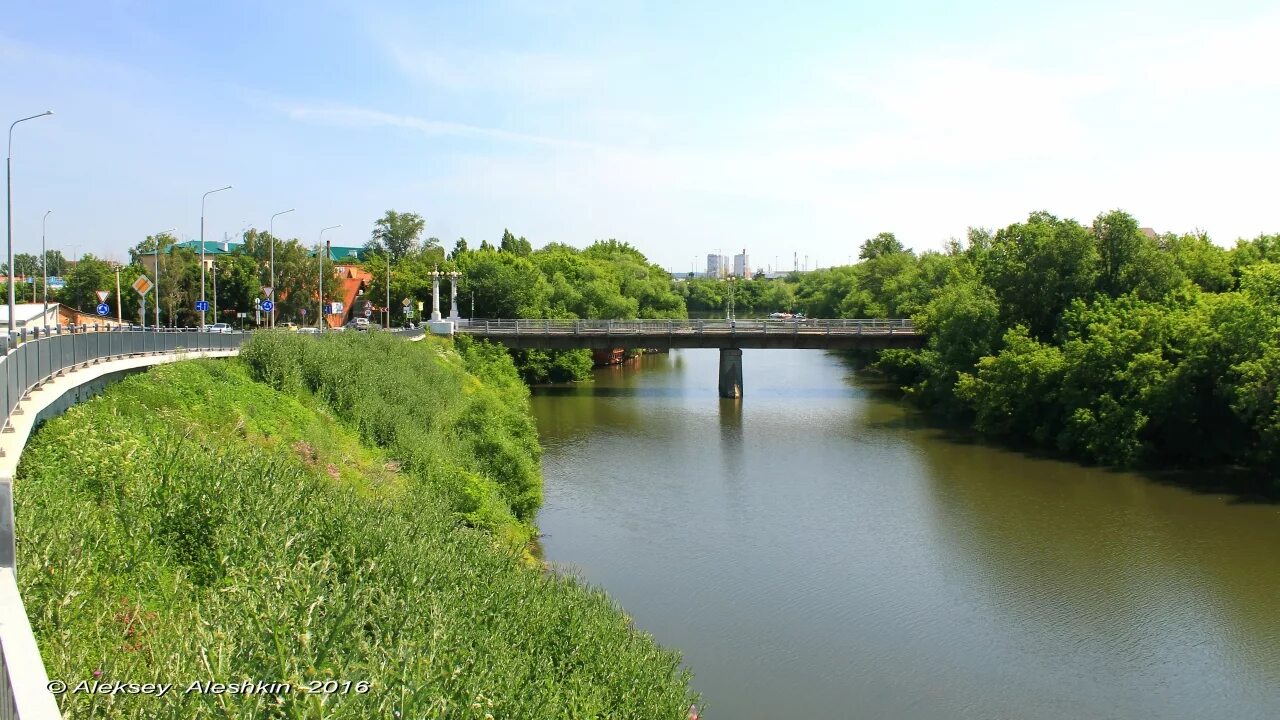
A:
[534,350,1280,720]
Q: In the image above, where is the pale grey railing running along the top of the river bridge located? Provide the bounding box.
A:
[457,319,915,336]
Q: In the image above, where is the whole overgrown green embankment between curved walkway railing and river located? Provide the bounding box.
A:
[17,334,691,719]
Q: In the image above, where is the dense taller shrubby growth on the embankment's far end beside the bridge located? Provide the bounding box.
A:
[241,333,541,546]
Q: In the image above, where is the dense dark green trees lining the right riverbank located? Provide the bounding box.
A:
[762,210,1280,482]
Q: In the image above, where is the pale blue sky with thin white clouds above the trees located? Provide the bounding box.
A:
[0,0,1280,272]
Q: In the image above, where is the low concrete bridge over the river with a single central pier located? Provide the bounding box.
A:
[453,319,924,397]
